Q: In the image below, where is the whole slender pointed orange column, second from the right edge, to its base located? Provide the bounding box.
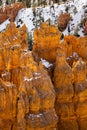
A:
[54,48,78,130]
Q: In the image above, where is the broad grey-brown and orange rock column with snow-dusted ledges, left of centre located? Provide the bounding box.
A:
[20,52,58,130]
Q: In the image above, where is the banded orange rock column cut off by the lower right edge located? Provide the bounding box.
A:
[72,59,87,130]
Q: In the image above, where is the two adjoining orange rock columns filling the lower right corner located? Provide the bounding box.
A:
[54,53,87,130]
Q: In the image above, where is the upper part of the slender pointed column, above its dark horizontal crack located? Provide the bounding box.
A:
[54,46,73,102]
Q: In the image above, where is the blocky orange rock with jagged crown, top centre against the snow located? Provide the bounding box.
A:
[33,23,61,62]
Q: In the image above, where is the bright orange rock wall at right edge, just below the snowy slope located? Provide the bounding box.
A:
[64,36,87,59]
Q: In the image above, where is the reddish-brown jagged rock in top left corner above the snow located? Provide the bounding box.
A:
[0,2,26,24]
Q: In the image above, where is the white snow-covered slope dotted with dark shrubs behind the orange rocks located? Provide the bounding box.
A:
[0,0,87,36]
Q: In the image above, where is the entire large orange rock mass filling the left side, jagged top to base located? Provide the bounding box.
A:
[0,23,58,130]
